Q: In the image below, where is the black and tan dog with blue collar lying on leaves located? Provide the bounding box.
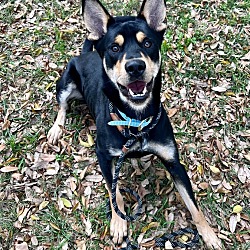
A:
[48,0,221,249]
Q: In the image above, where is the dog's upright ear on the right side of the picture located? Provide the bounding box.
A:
[138,0,166,32]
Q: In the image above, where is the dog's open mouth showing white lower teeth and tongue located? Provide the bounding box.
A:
[118,80,152,101]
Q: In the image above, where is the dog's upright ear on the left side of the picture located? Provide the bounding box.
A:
[82,0,113,40]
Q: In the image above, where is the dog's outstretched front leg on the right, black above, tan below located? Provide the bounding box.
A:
[164,161,222,249]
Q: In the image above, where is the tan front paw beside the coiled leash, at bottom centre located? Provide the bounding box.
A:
[110,213,128,245]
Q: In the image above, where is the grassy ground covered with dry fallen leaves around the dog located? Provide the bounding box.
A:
[0,0,250,250]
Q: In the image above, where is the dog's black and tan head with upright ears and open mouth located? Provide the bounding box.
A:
[83,0,166,111]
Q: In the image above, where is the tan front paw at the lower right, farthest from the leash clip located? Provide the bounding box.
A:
[198,227,222,250]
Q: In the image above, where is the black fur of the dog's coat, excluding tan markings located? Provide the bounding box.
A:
[57,0,196,204]
